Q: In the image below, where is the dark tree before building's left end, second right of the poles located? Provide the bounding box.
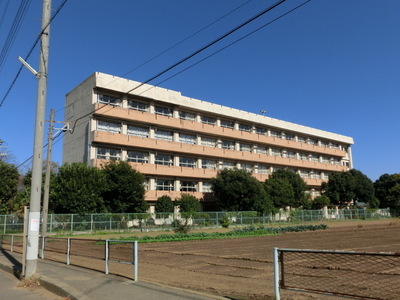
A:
[102,161,149,213]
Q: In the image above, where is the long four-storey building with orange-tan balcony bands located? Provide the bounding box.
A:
[63,73,353,209]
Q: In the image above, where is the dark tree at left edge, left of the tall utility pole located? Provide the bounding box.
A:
[0,160,19,214]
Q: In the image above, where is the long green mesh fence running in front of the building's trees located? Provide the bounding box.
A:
[0,207,396,234]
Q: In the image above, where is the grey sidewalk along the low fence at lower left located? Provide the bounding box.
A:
[0,249,226,300]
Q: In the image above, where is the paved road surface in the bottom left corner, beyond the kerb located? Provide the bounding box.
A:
[0,270,63,300]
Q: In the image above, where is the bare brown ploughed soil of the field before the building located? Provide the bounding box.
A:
[48,219,400,300]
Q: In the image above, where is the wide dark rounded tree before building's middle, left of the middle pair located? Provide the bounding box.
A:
[211,169,274,214]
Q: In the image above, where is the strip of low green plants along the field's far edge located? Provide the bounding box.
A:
[120,224,328,243]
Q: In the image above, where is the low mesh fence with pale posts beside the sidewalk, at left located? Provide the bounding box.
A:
[0,234,138,281]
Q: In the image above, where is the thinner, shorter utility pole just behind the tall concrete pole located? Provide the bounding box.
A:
[41,109,54,237]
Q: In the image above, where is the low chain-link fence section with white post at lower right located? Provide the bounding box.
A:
[273,248,400,300]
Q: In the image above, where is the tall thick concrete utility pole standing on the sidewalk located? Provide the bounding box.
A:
[25,0,51,278]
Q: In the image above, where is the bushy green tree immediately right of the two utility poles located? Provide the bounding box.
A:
[49,163,106,215]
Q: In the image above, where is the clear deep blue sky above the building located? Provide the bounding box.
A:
[0,0,400,180]
